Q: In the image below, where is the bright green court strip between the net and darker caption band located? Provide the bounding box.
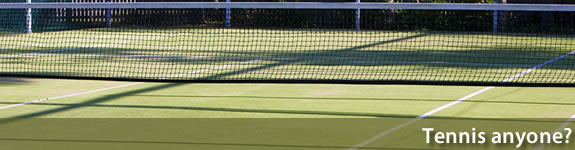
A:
[0,79,575,118]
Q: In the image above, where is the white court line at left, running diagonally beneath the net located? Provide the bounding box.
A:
[0,60,260,110]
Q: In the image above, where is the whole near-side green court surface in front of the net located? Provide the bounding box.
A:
[0,78,575,150]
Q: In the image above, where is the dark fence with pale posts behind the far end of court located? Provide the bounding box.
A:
[0,0,575,33]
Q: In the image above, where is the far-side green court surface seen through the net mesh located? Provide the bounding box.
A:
[0,28,575,83]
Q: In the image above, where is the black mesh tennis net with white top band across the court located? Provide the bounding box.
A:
[0,2,575,86]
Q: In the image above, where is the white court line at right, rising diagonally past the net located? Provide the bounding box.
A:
[347,50,575,150]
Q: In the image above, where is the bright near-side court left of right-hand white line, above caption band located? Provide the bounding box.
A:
[0,80,480,118]
